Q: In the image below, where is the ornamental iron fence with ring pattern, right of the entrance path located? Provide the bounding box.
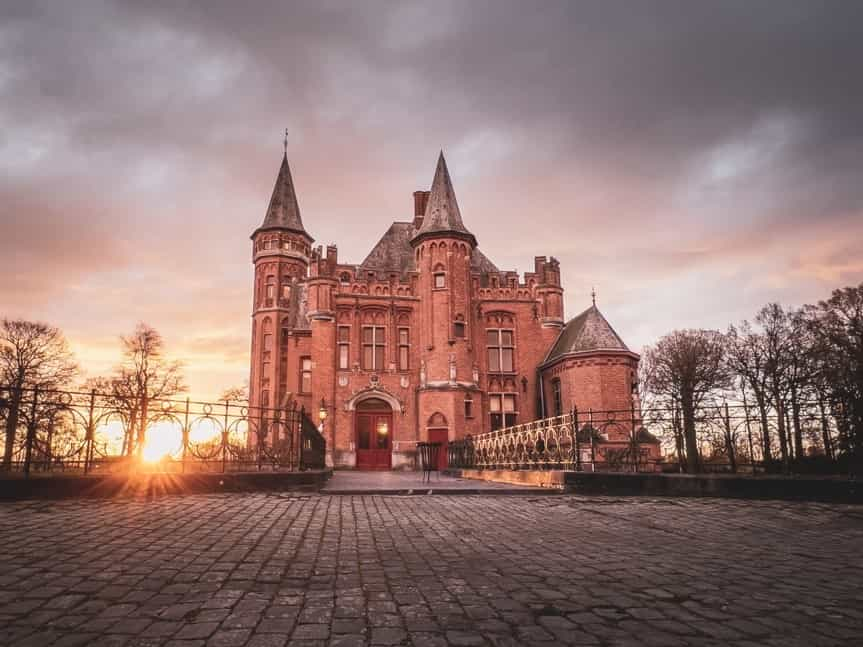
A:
[447,402,847,473]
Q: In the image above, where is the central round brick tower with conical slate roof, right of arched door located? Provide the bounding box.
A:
[411,152,477,440]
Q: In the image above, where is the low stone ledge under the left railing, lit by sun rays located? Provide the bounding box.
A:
[0,470,332,501]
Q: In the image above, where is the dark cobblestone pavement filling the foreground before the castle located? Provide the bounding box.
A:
[0,493,863,647]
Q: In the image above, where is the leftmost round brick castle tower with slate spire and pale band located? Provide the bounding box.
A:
[249,147,314,418]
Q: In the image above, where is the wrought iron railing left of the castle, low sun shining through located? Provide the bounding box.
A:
[0,386,326,475]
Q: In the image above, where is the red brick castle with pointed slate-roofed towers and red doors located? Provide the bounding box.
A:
[249,149,656,468]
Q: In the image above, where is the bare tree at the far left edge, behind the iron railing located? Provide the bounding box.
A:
[0,319,78,470]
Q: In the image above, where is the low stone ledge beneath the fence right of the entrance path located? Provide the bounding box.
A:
[447,470,863,504]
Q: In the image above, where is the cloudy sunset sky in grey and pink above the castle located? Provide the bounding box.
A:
[0,0,863,397]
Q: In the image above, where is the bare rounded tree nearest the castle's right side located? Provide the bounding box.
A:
[642,330,730,473]
